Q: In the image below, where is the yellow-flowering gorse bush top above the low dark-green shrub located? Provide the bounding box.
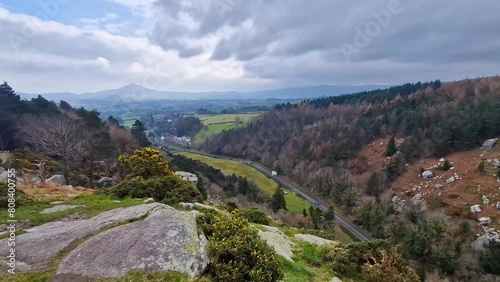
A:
[118,148,173,178]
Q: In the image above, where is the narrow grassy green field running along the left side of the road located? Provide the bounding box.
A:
[176,152,311,213]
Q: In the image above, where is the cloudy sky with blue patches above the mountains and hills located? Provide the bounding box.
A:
[0,0,500,93]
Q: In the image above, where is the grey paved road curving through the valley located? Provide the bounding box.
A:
[156,144,371,242]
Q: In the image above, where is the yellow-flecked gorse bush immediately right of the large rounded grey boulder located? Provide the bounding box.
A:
[198,210,283,282]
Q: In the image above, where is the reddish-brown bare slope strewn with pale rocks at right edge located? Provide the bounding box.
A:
[392,143,500,228]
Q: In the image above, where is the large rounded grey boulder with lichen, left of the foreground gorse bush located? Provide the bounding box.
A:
[57,206,209,281]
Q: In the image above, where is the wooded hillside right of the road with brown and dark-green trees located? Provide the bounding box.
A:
[203,77,500,281]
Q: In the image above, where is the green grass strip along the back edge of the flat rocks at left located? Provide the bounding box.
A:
[0,194,142,226]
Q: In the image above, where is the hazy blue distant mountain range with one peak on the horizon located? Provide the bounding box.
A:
[18,84,388,102]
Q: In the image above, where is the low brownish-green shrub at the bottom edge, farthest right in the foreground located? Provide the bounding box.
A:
[322,240,419,282]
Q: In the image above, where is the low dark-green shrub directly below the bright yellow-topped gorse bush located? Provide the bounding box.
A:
[109,175,202,204]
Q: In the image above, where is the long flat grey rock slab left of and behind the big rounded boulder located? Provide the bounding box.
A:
[0,203,164,268]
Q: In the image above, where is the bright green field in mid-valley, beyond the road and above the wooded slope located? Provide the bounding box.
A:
[193,113,260,145]
